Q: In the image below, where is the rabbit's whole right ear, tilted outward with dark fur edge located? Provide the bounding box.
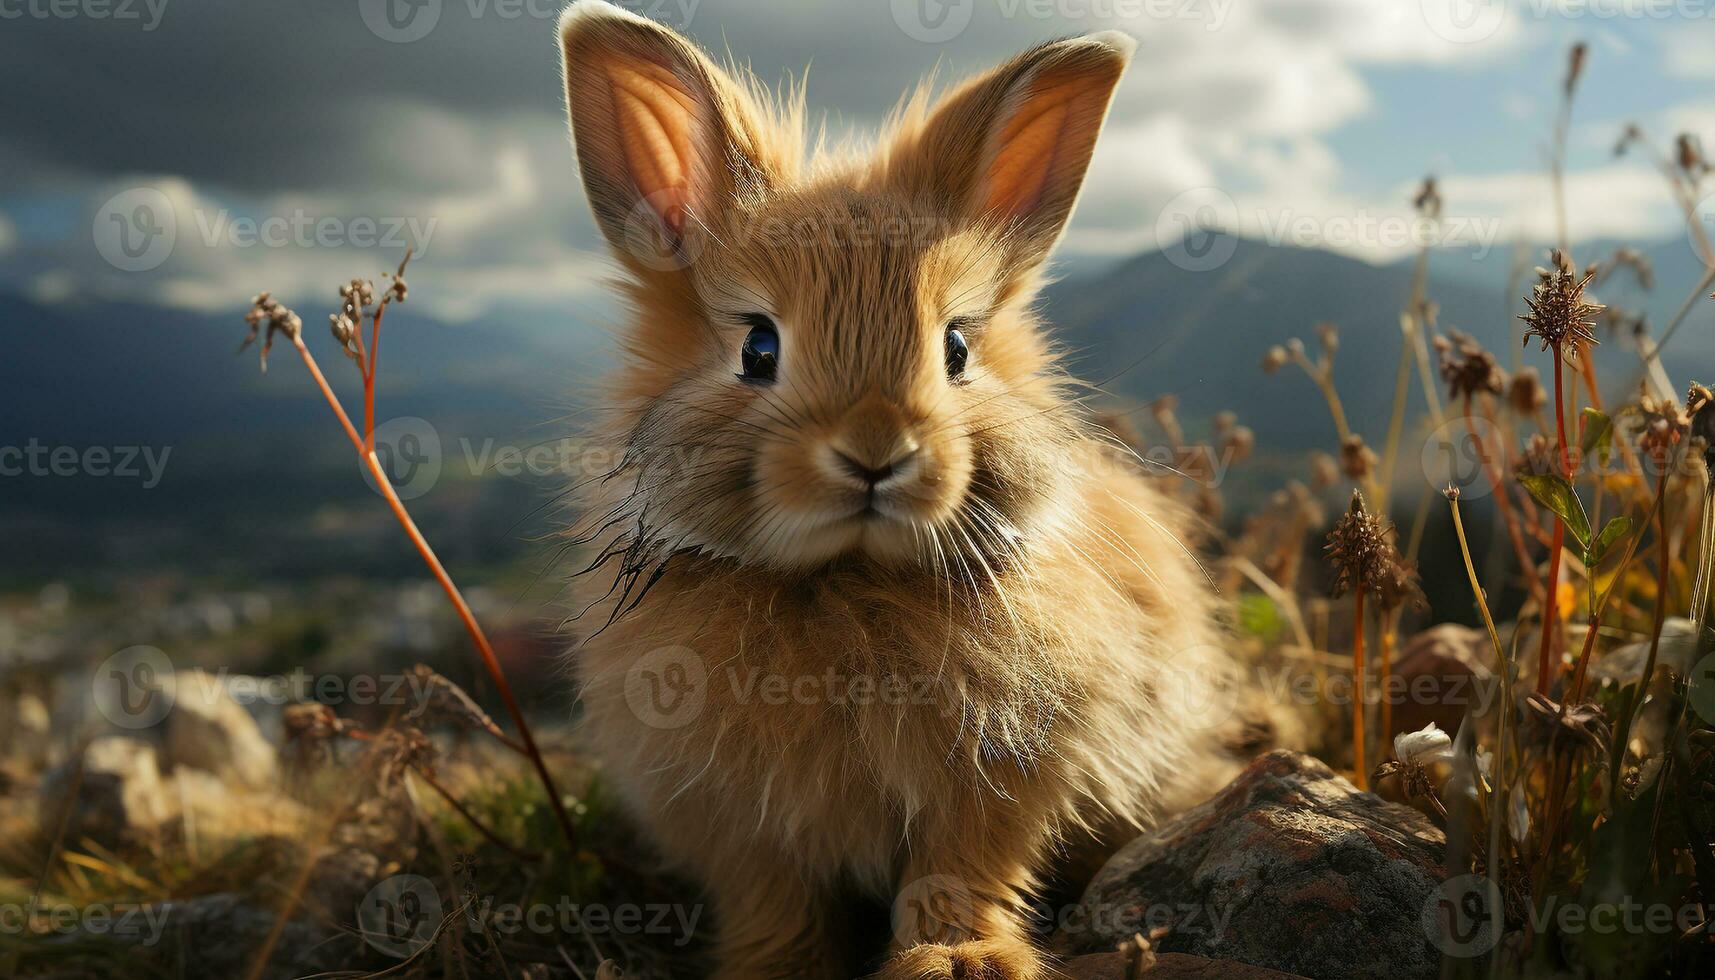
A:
[888,31,1137,264]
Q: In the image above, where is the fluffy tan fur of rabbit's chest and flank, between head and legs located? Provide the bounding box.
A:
[578,450,1221,884]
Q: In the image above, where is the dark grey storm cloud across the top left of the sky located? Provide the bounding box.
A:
[0,0,1125,194]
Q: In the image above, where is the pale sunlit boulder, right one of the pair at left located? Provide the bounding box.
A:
[166,671,280,788]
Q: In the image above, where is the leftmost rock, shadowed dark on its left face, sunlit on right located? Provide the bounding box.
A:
[39,735,173,843]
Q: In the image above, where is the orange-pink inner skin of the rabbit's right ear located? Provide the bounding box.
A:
[983,79,1094,218]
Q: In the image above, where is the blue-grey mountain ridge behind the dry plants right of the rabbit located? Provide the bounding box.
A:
[1046,240,1715,451]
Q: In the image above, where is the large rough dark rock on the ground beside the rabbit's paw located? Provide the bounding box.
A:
[1056,752,1444,980]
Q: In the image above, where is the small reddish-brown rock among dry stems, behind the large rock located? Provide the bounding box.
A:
[1375,623,1494,743]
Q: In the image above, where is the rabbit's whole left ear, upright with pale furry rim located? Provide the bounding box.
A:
[559,0,767,264]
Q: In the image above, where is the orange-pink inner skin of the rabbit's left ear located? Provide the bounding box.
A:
[607,64,696,235]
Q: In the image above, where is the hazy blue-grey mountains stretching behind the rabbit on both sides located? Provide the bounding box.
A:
[0,242,1715,589]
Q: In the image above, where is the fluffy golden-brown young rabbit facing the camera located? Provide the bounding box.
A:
[559,0,1275,980]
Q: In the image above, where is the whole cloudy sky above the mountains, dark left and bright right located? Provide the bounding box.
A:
[0,0,1715,321]
